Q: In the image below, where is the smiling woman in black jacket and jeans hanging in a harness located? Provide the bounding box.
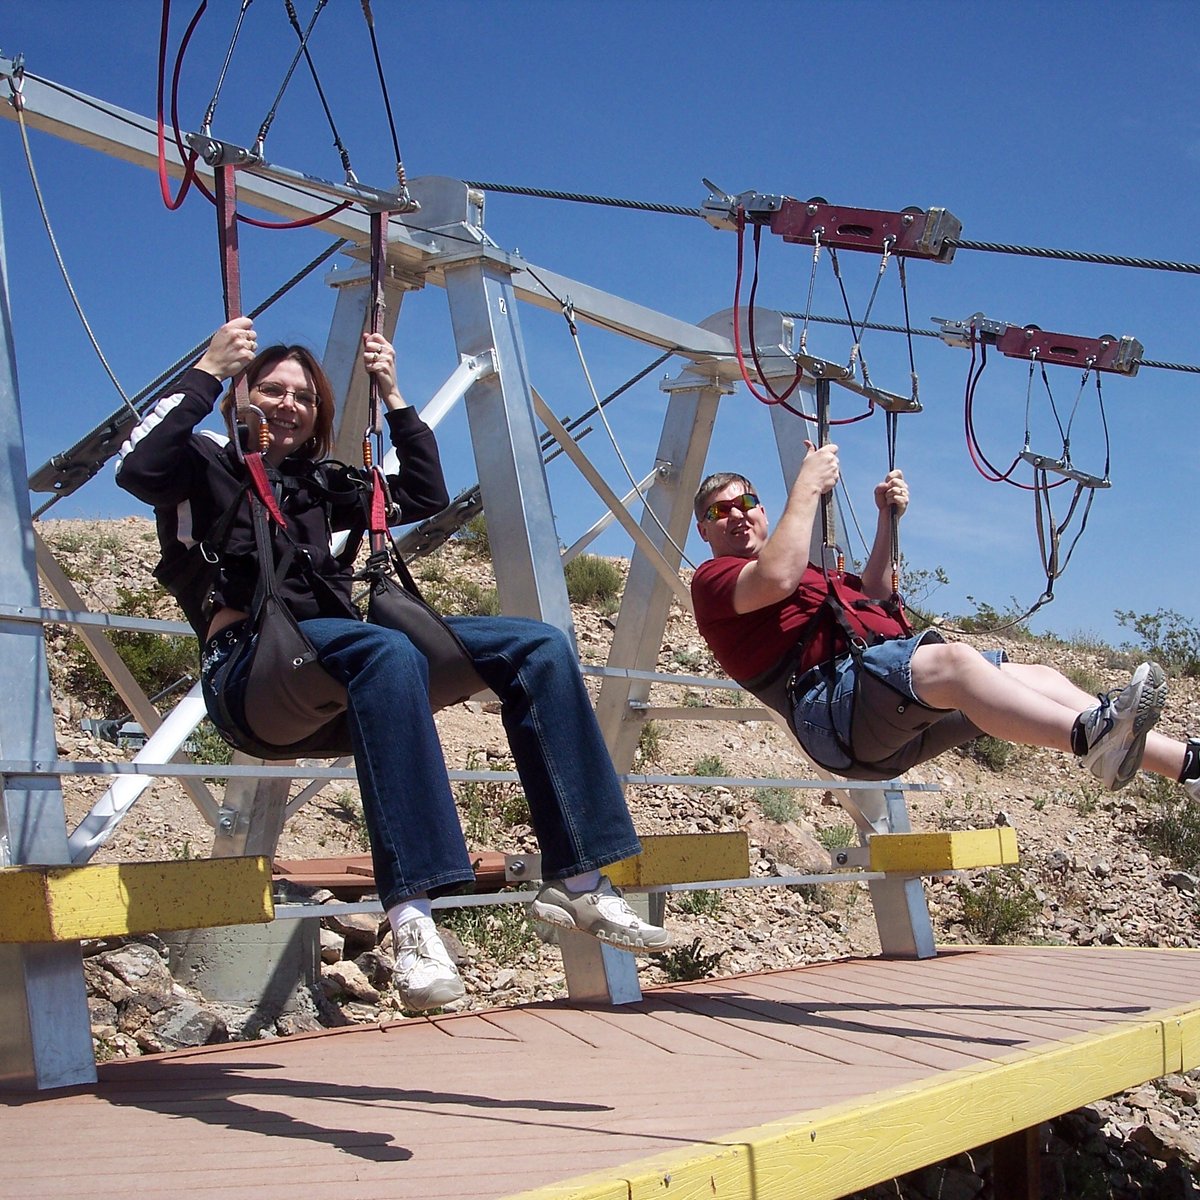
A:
[116,318,670,1012]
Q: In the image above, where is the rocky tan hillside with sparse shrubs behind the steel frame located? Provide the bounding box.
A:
[32,518,1200,1196]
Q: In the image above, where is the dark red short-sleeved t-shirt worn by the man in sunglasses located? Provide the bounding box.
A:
[691,556,908,679]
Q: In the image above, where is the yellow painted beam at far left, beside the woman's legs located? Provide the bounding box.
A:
[0,858,275,942]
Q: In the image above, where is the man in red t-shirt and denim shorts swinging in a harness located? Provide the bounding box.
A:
[691,443,1200,799]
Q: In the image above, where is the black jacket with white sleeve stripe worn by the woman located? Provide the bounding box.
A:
[116,370,449,640]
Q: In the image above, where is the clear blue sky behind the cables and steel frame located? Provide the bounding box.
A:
[0,0,1200,641]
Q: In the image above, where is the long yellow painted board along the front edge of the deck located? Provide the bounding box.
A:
[506,1006,1200,1200]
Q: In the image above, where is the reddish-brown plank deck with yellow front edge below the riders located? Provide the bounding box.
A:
[0,947,1200,1200]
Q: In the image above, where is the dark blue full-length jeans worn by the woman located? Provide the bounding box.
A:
[208,617,641,908]
